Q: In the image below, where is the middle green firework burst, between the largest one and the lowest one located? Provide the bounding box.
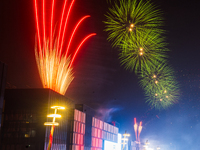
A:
[119,30,168,74]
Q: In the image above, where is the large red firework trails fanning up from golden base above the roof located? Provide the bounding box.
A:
[34,0,96,95]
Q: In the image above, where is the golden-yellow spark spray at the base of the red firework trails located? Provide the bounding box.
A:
[35,40,74,95]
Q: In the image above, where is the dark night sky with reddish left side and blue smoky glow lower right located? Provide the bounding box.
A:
[0,0,200,150]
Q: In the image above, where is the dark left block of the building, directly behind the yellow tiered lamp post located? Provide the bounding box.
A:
[0,89,72,150]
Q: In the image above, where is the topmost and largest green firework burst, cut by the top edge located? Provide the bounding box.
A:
[104,0,163,46]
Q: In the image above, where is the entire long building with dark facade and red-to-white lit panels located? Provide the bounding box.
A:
[0,89,118,150]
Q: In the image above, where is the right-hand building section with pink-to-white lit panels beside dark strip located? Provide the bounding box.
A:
[74,104,119,150]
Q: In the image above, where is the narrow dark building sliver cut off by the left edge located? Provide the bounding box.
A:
[0,62,7,129]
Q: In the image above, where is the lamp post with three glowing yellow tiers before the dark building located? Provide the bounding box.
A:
[44,106,65,150]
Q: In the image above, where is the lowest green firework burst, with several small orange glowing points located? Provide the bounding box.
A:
[140,64,180,109]
